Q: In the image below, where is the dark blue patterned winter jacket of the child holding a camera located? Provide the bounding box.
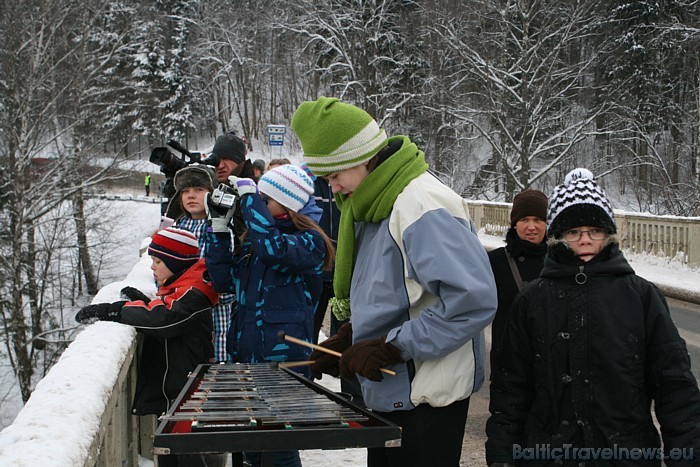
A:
[205,194,326,376]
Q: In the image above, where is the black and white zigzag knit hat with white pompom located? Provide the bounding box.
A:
[547,168,617,238]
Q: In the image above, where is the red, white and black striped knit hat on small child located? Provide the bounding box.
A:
[148,227,199,274]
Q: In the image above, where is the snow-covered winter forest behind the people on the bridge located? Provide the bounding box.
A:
[0,0,700,424]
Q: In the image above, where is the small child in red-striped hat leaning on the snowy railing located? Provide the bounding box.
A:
[75,227,219,467]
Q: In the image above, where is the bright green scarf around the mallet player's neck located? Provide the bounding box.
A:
[330,136,428,321]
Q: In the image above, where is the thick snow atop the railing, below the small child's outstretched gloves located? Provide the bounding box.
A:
[0,323,136,467]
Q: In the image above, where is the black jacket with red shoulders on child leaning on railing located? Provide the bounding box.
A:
[120,259,218,415]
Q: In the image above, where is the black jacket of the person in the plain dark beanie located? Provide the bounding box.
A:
[489,227,547,360]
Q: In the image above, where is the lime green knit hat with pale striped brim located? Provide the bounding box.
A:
[292,97,387,176]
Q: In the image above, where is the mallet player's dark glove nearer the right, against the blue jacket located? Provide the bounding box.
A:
[339,336,403,381]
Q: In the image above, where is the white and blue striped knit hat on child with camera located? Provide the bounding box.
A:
[258,164,314,212]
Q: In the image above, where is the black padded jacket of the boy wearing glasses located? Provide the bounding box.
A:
[486,243,700,466]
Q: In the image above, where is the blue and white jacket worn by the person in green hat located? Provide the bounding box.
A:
[350,172,497,411]
